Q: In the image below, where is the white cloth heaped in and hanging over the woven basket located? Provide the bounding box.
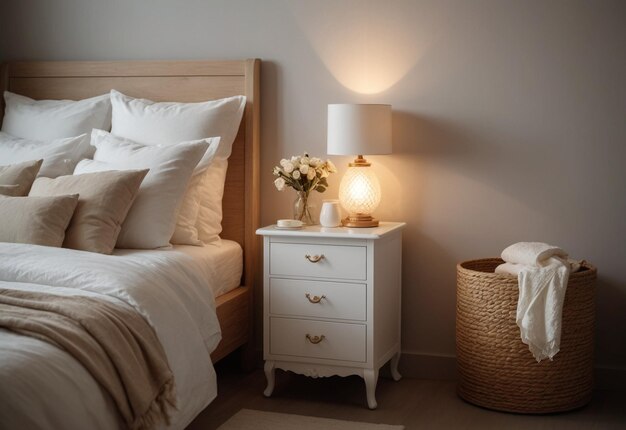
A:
[496,242,570,362]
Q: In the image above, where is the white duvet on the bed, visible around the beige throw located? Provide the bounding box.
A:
[0,243,220,430]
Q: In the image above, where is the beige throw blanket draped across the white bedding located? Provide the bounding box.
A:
[0,288,176,429]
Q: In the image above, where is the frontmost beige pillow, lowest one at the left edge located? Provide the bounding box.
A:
[0,194,78,247]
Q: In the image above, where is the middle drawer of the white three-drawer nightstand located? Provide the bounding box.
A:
[270,278,367,321]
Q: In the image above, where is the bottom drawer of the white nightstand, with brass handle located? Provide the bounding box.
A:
[270,318,367,362]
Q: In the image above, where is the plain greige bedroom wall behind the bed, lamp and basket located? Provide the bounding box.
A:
[0,0,626,368]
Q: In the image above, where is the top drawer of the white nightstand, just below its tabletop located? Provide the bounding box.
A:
[270,242,367,280]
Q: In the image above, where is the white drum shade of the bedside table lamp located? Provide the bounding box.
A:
[327,104,391,155]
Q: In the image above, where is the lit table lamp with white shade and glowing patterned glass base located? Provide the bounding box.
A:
[327,104,391,227]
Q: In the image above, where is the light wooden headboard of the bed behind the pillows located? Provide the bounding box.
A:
[0,59,260,286]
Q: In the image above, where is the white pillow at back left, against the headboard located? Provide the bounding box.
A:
[2,91,111,140]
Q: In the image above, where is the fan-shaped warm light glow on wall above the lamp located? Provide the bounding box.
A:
[285,0,423,94]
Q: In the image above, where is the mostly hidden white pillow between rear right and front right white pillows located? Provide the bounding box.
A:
[91,129,220,245]
